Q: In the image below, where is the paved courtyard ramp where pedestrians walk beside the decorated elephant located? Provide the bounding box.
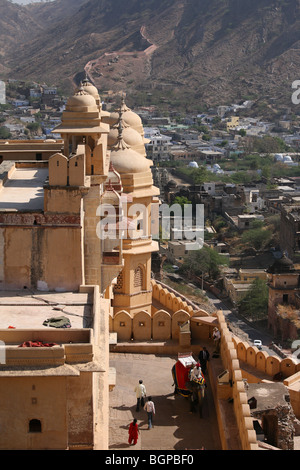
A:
[109,353,221,451]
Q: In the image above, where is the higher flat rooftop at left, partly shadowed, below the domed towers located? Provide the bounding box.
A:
[0,168,48,211]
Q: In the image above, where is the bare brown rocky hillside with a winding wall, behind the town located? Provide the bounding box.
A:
[0,0,300,106]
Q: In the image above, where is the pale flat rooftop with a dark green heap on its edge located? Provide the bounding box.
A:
[0,290,93,330]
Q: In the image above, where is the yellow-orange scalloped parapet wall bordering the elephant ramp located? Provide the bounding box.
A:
[110,280,300,450]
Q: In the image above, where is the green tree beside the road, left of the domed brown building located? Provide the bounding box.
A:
[238,278,269,320]
